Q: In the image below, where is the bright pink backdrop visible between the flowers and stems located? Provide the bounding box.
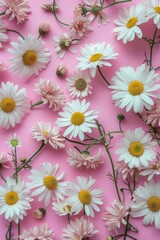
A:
[0,0,159,240]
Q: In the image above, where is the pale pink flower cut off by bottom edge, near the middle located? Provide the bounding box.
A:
[62,217,99,240]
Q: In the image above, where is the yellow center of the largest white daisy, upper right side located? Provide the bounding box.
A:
[128,80,144,96]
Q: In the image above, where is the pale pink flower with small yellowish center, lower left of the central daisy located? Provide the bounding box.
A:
[31,122,65,150]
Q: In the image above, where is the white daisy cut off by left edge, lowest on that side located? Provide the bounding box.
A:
[0,177,33,223]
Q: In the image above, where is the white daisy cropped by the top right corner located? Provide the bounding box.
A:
[144,0,160,29]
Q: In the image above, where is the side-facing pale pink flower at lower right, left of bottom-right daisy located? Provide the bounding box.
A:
[103,200,129,233]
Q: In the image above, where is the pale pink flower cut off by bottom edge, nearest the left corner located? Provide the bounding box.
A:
[20,223,54,240]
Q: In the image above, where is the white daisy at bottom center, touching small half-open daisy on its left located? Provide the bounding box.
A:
[66,176,103,217]
